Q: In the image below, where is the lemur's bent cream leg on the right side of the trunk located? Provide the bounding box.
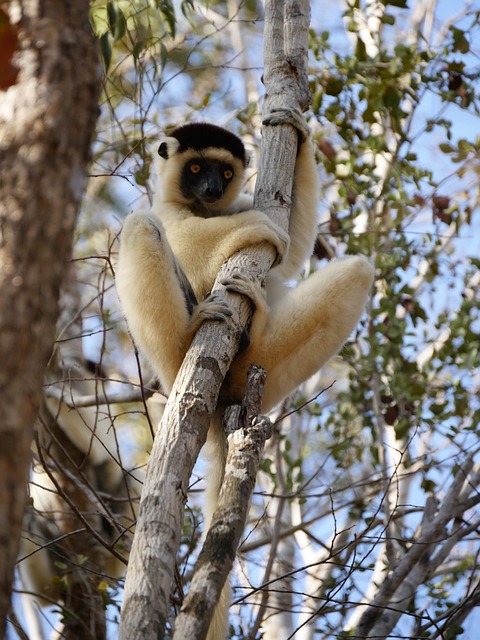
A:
[227,256,373,411]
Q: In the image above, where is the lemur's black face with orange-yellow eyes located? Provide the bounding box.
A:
[181,158,234,209]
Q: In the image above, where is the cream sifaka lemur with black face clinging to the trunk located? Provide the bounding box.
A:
[116,109,373,640]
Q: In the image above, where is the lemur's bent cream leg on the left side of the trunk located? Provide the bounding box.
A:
[115,213,230,393]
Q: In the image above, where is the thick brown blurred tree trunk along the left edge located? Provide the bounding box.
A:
[0,0,100,636]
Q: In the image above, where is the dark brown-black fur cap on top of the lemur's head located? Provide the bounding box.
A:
[168,122,247,166]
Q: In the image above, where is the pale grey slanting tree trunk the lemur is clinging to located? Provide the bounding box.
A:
[119,0,310,640]
